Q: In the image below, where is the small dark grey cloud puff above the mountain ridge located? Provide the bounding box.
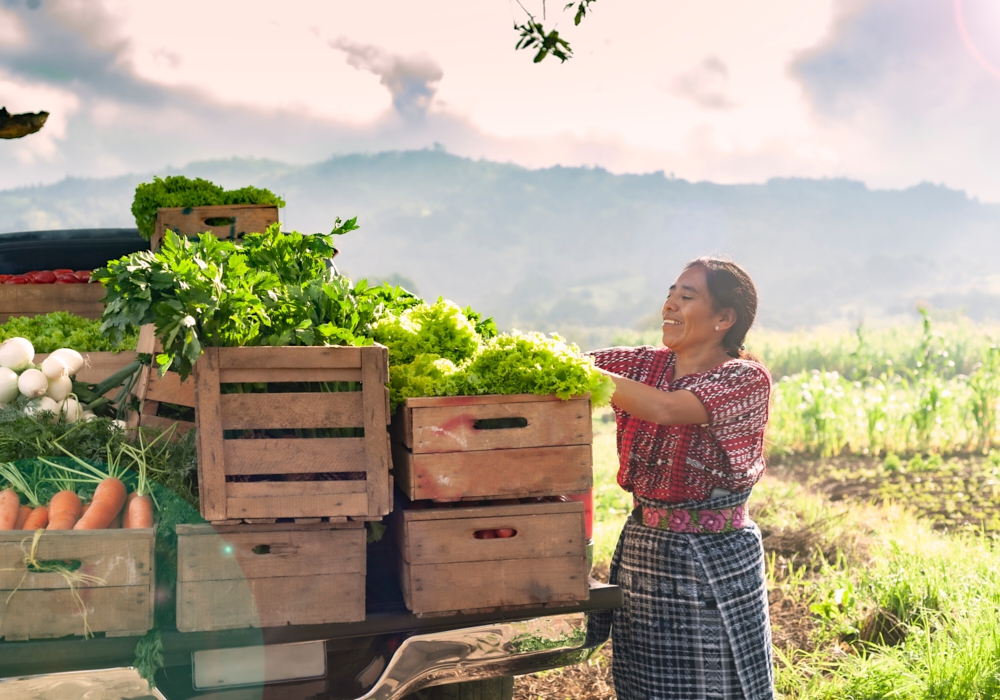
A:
[330,37,444,118]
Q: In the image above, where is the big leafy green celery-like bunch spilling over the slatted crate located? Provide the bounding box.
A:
[94,226,416,378]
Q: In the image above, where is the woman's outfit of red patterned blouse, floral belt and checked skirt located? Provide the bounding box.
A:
[591,346,774,700]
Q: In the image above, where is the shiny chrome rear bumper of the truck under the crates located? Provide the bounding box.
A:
[0,613,606,700]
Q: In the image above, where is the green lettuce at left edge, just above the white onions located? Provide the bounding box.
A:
[0,311,138,353]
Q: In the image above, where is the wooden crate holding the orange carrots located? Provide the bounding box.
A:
[0,528,155,641]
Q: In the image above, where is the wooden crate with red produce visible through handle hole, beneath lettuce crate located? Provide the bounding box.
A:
[389,501,590,614]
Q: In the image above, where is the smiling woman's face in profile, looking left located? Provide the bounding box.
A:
[661,266,733,351]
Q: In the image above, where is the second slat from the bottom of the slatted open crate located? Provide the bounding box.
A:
[223,438,365,475]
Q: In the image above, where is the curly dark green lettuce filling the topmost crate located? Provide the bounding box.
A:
[132,175,285,238]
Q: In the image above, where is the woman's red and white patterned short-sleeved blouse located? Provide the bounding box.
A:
[591,345,771,503]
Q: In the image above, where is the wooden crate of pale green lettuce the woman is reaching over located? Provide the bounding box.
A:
[392,394,593,501]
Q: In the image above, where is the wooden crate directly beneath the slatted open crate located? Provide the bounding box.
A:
[177,522,366,632]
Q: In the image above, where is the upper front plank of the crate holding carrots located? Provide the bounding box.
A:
[0,528,154,591]
